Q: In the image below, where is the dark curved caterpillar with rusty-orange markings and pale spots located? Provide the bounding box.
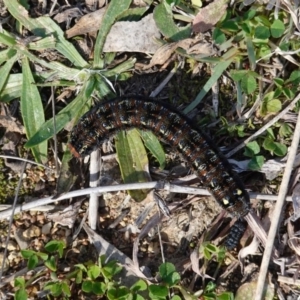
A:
[69,96,250,218]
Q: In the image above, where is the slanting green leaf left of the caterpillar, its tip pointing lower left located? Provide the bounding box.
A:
[25,77,94,148]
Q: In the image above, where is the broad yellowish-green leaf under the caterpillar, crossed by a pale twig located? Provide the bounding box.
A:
[115,129,150,201]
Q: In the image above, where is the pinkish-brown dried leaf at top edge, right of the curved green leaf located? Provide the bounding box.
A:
[193,0,228,33]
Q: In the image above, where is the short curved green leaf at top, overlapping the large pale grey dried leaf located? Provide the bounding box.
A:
[153,1,192,41]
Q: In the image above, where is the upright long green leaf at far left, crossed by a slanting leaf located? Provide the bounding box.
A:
[21,57,48,163]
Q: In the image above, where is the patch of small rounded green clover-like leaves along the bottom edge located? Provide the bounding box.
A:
[14,241,233,300]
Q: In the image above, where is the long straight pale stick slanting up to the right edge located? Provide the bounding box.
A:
[255,106,300,300]
